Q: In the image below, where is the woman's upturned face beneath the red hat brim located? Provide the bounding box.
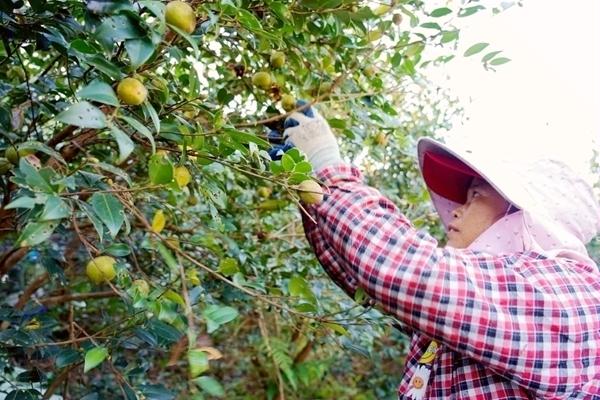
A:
[446,178,509,249]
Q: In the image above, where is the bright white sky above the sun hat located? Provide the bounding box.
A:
[440,0,600,184]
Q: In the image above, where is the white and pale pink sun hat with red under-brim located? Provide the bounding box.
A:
[417,138,600,264]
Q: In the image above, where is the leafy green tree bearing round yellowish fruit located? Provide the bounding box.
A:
[0,0,508,400]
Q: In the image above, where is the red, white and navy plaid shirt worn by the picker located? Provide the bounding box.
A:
[303,165,600,400]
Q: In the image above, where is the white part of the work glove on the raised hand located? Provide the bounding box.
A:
[283,108,342,172]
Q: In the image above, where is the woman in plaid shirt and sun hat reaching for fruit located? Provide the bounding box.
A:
[270,103,600,399]
